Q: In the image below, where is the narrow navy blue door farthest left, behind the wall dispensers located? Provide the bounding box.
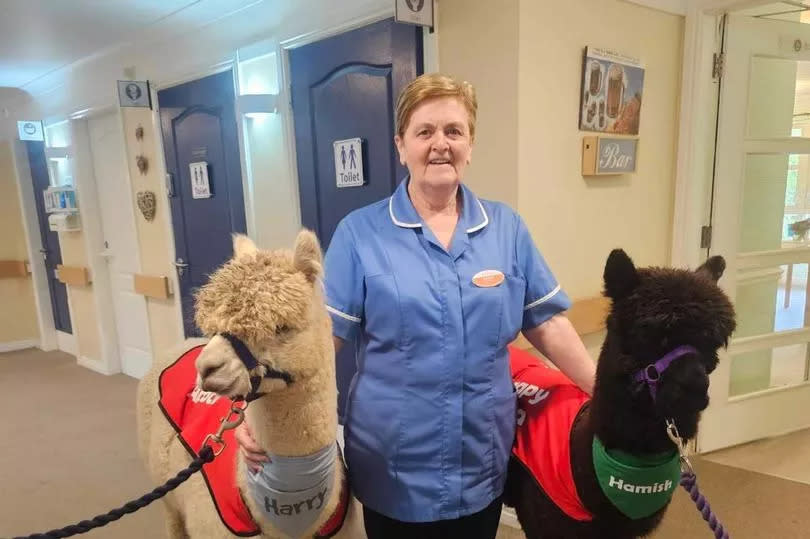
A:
[25,141,73,333]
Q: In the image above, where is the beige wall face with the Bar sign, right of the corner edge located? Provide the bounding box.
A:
[518,0,684,299]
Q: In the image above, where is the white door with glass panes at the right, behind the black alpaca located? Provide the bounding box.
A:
[698,11,810,451]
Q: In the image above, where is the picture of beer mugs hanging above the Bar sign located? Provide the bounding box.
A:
[579,47,644,135]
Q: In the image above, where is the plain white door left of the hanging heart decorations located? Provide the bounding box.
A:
[89,112,152,378]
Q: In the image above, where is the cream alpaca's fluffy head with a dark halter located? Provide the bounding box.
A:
[195,230,334,397]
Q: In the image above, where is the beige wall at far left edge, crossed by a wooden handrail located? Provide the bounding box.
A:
[0,142,39,345]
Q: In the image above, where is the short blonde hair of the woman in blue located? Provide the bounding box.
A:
[397,73,478,140]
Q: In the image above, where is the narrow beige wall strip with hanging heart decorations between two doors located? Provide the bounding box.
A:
[121,108,183,353]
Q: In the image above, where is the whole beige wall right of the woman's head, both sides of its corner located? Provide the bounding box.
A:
[439,0,684,300]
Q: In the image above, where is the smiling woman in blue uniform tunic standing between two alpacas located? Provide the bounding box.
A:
[238,74,595,539]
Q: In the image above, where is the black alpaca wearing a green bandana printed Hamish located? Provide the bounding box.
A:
[504,250,735,539]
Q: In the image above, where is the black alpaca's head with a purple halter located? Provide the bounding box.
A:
[598,249,735,438]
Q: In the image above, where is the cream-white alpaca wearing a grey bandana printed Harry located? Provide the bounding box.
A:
[138,231,365,539]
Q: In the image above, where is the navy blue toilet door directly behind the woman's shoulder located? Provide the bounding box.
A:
[290,19,422,421]
